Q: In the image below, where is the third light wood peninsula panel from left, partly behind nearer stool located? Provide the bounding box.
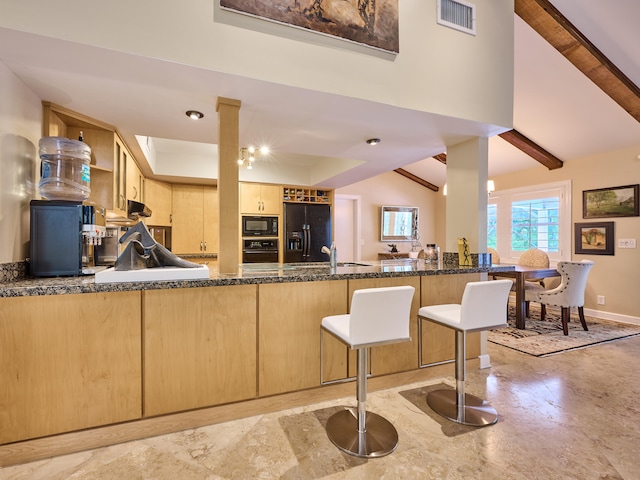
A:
[258,280,348,396]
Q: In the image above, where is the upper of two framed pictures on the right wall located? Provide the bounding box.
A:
[582,185,640,218]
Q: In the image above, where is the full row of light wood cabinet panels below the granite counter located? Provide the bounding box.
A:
[0,274,488,450]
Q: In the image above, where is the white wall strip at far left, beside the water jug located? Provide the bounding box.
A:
[0,62,42,263]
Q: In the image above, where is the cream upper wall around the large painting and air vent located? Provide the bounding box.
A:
[0,0,514,130]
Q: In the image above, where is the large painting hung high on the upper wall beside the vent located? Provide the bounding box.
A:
[220,0,399,53]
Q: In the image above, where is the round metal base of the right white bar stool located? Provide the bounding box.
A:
[427,390,498,427]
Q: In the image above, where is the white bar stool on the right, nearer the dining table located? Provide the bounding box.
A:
[418,280,513,427]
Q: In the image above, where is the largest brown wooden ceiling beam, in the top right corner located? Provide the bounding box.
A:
[515,0,640,122]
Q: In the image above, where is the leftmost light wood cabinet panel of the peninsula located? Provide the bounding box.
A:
[0,292,142,444]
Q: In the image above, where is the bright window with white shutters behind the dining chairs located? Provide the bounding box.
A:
[487,181,571,263]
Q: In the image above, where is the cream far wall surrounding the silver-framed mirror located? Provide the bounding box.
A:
[335,172,438,260]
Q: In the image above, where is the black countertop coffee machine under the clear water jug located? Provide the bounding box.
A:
[30,200,106,277]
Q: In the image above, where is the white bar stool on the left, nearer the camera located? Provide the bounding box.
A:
[321,286,415,458]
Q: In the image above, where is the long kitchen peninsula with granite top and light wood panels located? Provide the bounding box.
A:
[0,260,513,466]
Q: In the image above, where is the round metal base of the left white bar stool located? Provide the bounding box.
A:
[327,408,398,458]
